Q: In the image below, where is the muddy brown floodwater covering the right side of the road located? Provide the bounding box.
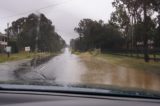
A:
[81,55,160,91]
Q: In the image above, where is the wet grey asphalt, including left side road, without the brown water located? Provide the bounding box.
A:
[0,48,86,84]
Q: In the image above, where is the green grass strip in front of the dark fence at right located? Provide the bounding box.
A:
[99,54,160,72]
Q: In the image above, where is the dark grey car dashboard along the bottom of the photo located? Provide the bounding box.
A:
[0,90,160,106]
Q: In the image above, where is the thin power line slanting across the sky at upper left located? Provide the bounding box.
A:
[1,0,73,19]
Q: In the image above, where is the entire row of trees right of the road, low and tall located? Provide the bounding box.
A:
[71,0,160,62]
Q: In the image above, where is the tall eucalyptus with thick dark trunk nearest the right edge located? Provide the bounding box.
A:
[113,0,158,62]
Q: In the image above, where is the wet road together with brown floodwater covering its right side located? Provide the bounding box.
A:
[0,48,160,91]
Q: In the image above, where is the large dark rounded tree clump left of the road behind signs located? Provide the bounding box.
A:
[6,14,66,52]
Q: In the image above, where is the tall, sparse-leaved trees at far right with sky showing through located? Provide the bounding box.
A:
[111,0,160,62]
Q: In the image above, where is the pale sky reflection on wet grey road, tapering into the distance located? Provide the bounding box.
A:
[36,48,86,84]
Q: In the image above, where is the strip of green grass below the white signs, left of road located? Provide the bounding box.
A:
[0,52,51,63]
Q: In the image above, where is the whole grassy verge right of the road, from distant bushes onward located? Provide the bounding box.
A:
[76,52,160,72]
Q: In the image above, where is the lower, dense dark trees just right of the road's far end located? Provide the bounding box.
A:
[71,19,123,51]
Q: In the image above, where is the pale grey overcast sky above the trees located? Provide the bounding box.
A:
[0,0,114,43]
